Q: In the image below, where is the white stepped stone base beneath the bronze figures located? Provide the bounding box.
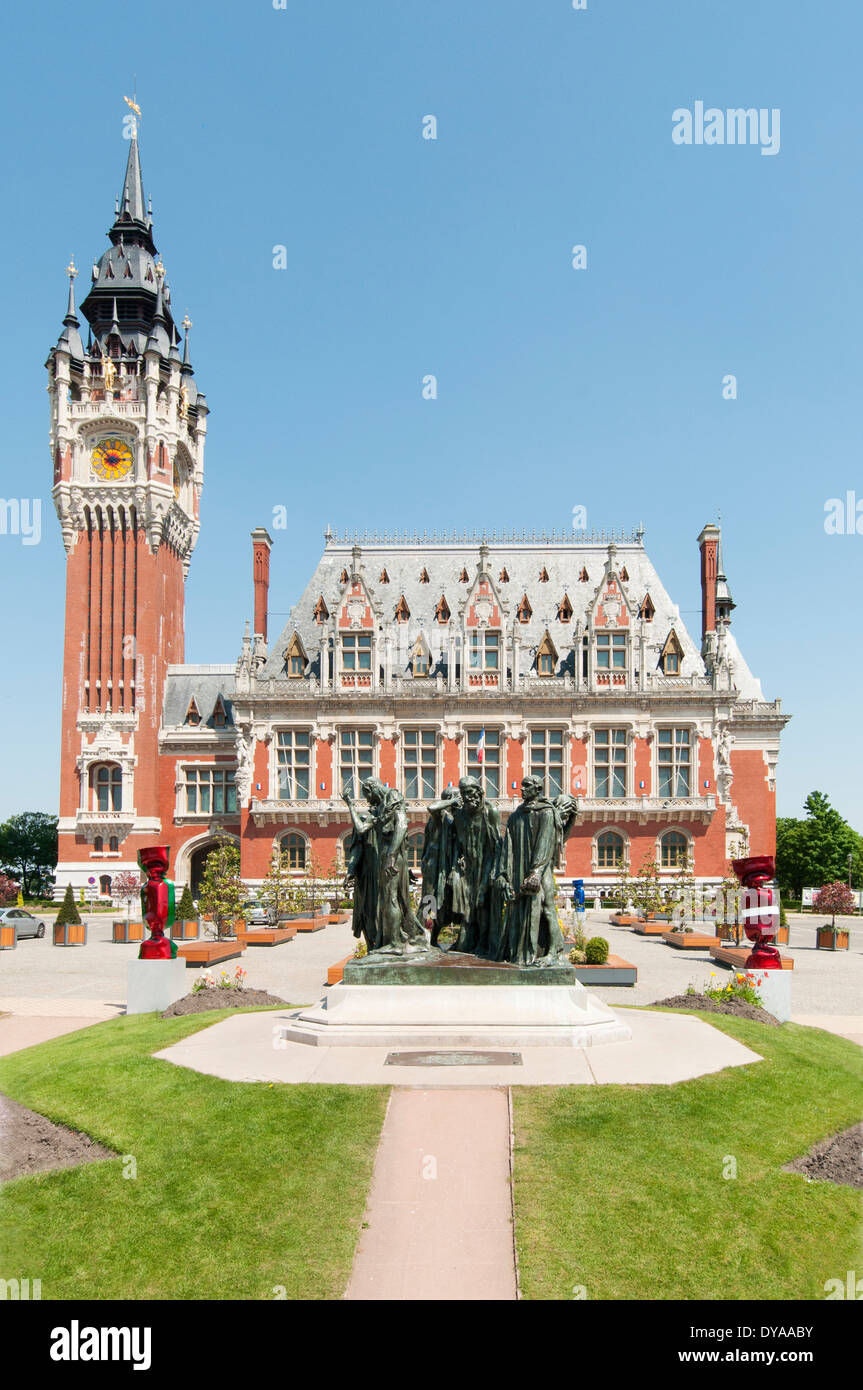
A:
[281,984,632,1048]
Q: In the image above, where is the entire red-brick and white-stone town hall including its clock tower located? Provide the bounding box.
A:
[47,135,788,895]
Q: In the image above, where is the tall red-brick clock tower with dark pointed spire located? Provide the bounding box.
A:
[46,125,207,891]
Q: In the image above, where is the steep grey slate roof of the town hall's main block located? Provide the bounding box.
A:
[261,531,733,681]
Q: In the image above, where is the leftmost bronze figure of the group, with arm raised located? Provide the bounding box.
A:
[343,777,428,956]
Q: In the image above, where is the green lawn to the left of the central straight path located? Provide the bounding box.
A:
[0,1011,388,1298]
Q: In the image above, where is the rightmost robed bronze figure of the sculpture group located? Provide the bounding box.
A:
[498,777,577,966]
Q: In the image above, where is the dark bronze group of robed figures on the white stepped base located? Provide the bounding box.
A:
[345,777,577,966]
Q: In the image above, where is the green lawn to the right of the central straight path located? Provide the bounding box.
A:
[513,1015,863,1300]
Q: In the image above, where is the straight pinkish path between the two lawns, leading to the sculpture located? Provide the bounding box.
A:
[345,1087,518,1302]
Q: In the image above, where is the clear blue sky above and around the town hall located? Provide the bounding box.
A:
[0,0,863,830]
